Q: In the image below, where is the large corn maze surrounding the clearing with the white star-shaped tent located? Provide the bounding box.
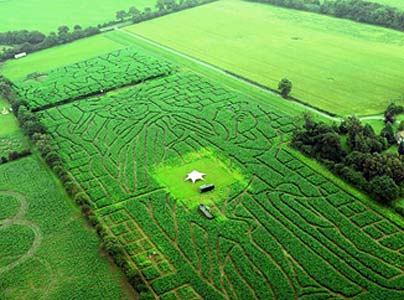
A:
[39,71,404,300]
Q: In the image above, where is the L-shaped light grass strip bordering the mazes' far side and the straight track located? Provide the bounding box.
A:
[0,31,312,122]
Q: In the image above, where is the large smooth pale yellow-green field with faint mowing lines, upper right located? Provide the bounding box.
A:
[126,0,404,115]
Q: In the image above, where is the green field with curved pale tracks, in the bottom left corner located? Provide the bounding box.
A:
[0,156,133,300]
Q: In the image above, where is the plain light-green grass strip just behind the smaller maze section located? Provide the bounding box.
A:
[0,35,123,80]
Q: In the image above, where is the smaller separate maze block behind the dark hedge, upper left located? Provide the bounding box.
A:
[15,48,174,109]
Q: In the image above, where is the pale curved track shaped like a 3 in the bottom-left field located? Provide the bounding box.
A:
[0,191,42,276]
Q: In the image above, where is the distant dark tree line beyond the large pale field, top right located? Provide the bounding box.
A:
[247,0,404,30]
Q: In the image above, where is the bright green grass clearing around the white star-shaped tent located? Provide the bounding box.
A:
[154,152,246,208]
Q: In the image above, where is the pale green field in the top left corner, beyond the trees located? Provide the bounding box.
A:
[0,0,156,33]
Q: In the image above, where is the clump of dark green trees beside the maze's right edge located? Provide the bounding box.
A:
[291,103,404,212]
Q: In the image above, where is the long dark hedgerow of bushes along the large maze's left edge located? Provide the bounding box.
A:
[0,75,154,300]
